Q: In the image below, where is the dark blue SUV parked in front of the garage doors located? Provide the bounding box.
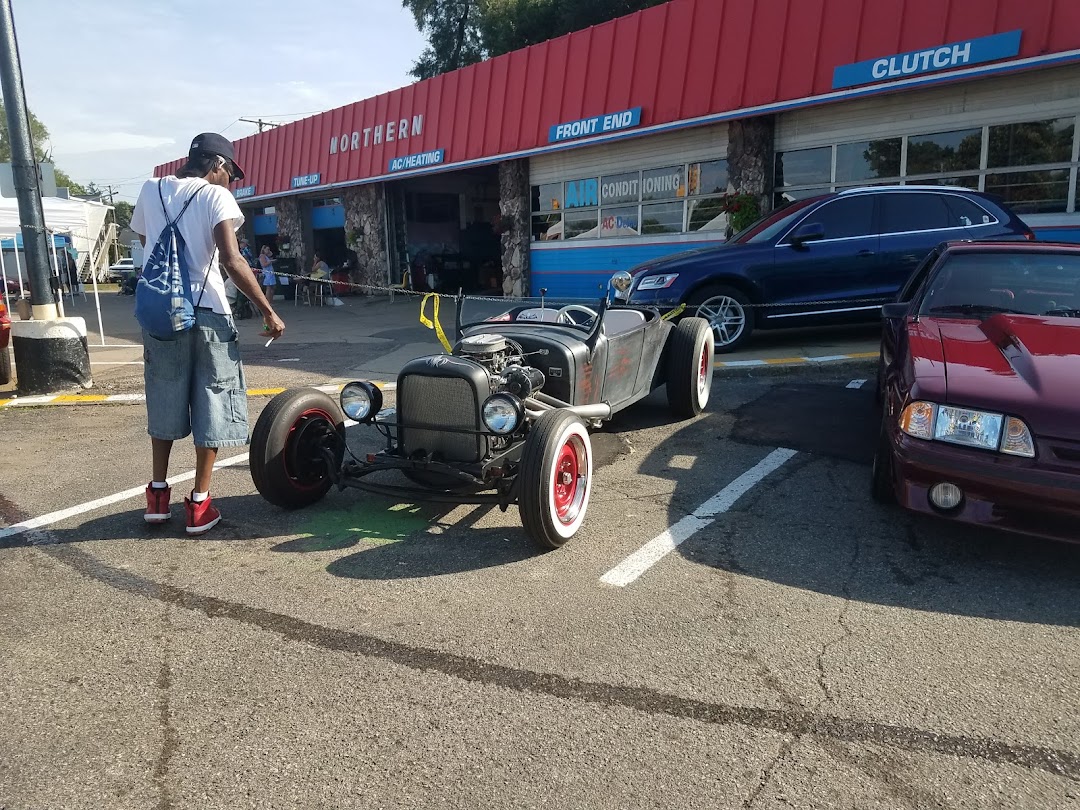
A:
[629,186,1035,352]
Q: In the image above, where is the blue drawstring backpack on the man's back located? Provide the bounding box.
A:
[135,181,210,340]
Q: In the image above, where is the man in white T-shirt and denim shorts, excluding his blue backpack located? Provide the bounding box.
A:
[131,133,285,535]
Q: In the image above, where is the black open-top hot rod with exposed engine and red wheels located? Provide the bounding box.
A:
[251,273,714,549]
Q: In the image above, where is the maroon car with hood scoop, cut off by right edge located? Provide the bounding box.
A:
[873,242,1080,541]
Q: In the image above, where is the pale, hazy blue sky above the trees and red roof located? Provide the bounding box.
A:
[12,0,424,202]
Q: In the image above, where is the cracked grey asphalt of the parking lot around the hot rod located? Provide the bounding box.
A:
[0,362,1080,810]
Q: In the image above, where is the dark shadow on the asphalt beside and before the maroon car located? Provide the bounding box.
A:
[640,384,1080,626]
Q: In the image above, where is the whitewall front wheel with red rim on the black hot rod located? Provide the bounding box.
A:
[517,410,593,549]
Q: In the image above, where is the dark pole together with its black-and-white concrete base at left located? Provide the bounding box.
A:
[0,0,93,394]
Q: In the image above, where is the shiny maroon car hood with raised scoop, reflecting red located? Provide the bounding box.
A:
[908,314,1080,442]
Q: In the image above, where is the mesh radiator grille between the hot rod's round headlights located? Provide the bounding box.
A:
[397,374,484,463]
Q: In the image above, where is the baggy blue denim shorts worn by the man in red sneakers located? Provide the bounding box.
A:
[143,309,247,447]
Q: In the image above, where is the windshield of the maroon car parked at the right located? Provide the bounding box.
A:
[919,251,1080,318]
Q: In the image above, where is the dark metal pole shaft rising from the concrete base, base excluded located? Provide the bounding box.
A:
[0,0,57,321]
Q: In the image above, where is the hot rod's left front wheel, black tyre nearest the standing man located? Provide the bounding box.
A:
[249,388,345,509]
